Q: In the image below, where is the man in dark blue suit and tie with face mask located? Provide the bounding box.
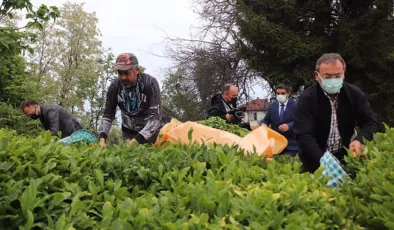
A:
[261,84,298,157]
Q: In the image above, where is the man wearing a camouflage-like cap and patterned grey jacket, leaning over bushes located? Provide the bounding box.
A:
[99,53,161,147]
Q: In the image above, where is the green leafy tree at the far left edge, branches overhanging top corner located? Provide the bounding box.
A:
[0,0,59,105]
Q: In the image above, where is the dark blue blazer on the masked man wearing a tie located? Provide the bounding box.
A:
[261,98,298,151]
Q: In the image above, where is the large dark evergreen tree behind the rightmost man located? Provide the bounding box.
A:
[237,0,394,124]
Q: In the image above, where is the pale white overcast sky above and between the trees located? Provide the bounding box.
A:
[32,0,264,98]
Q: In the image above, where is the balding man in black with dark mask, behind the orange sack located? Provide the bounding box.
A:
[208,84,250,130]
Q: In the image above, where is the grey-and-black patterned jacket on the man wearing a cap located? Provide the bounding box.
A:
[99,73,161,143]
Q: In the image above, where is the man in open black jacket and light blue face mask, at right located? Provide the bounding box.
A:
[294,53,379,172]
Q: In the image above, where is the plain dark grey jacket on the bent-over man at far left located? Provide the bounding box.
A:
[39,104,82,138]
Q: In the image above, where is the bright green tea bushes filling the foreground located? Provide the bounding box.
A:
[0,128,394,229]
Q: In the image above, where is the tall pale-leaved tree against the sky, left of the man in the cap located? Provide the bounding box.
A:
[52,3,102,111]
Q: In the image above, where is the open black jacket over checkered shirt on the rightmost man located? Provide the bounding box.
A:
[294,83,379,172]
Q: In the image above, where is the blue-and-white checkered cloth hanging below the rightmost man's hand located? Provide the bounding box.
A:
[320,151,350,188]
